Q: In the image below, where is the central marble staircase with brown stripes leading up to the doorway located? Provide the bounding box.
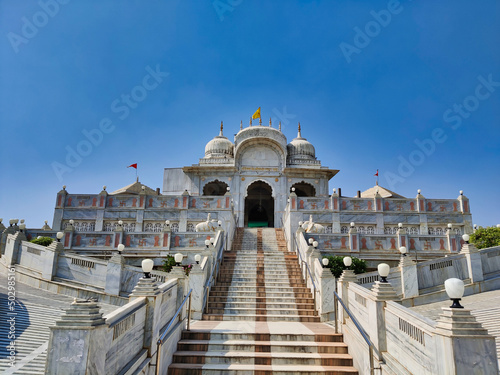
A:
[169,228,358,375]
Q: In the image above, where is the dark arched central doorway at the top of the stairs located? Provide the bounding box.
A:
[245,181,274,227]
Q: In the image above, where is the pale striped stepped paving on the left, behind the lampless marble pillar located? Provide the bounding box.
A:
[0,272,118,375]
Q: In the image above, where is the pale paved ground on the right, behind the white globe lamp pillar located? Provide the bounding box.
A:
[411,290,500,361]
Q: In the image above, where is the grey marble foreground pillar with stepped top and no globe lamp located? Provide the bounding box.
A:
[45,298,109,375]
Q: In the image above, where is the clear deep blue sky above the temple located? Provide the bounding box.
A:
[0,0,500,227]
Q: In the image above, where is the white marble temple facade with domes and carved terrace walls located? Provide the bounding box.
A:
[30,119,472,262]
